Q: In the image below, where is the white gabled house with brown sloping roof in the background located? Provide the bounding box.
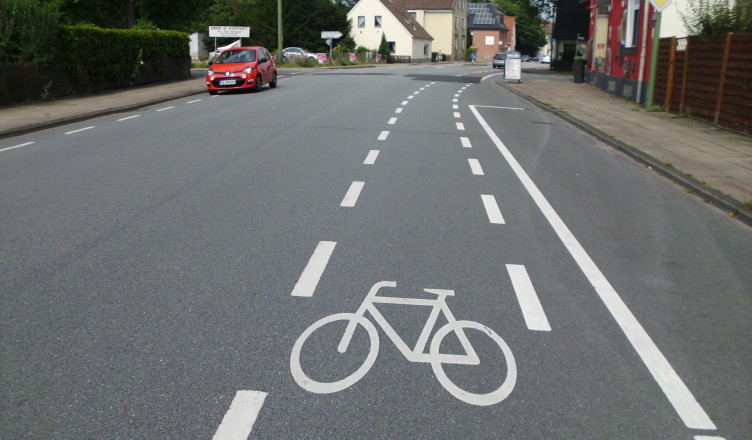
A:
[347,0,435,61]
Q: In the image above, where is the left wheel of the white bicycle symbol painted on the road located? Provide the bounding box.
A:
[290,313,379,394]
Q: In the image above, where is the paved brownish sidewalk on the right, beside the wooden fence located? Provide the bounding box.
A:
[498,71,752,225]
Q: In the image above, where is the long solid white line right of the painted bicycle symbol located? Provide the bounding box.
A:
[470,105,717,430]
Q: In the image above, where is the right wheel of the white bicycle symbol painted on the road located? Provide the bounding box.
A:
[430,321,517,406]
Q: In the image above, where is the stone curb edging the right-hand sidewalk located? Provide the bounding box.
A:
[496,81,752,230]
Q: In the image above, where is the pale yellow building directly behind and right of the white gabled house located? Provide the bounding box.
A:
[402,0,468,60]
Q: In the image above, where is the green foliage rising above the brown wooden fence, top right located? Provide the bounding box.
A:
[680,0,752,35]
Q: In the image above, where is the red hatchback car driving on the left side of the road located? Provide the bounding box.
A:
[206,47,277,95]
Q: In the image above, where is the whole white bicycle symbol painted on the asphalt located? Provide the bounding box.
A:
[290,281,517,406]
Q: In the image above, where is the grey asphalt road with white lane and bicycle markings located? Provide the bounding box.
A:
[0,65,752,440]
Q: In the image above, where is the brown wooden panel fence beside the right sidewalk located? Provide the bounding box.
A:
[655,34,752,134]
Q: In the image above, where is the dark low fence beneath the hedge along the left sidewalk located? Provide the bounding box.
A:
[0,58,191,106]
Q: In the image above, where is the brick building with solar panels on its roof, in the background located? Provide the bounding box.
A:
[467,3,509,61]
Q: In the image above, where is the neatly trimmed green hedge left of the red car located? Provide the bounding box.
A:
[61,26,190,86]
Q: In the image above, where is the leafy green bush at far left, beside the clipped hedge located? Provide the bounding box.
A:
[0,0,60,64]
